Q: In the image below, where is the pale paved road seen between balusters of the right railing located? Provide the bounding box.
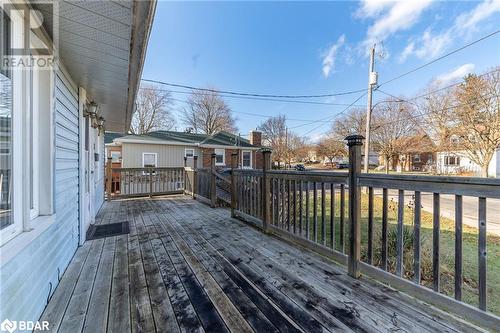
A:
[374,189,500,236]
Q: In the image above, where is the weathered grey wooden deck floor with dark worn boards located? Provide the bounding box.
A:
[41,196,484,333]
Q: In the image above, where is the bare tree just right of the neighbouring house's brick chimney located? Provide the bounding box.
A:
[258,115,286,165]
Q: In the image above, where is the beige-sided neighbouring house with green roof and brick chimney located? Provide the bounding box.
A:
[106,131,263,169]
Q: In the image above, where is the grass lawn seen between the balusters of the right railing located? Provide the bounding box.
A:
[278,191,500,315]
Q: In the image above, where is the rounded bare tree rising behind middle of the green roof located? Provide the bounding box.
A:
[182,90,237,135]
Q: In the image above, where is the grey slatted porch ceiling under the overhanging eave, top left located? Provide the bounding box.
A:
[34,0,156,132]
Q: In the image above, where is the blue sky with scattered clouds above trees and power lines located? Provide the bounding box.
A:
[143,0,500,141]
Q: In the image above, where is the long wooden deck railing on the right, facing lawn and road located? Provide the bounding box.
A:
[231,136,500,328]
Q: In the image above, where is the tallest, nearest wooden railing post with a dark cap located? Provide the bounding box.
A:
[345,135,364,278]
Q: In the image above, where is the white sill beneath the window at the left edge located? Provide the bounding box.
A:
[0,214,56,267]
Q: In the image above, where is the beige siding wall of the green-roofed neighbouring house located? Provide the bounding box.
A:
[122,143,203,168]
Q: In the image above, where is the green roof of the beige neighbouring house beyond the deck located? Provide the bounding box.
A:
[115,131,256,147]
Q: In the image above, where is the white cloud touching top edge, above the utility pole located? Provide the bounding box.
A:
[358,0,432,46]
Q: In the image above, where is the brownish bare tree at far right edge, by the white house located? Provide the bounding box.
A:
[451,67,500,177]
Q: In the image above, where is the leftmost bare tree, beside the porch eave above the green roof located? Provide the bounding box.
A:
[130,86,175,134]
